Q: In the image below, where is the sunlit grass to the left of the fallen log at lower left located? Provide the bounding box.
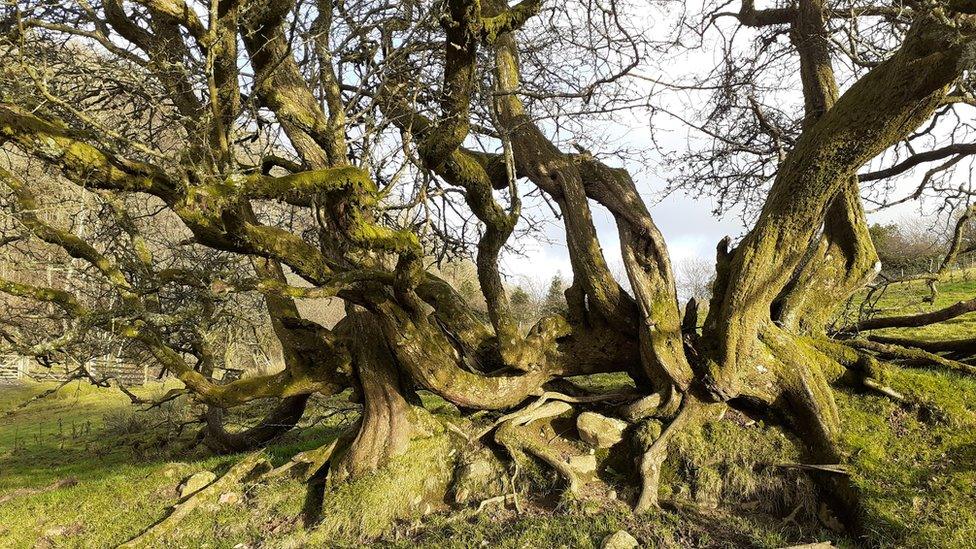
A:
[0,383,238,547]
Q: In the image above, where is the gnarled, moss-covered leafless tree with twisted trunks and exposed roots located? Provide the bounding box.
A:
[0,0,976,532]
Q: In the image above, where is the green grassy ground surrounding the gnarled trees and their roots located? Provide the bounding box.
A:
[0,273,976,548]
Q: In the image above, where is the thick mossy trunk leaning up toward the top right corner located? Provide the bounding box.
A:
[706,12,970,398]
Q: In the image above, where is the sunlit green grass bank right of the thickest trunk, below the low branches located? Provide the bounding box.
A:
[838,370,976,548]
